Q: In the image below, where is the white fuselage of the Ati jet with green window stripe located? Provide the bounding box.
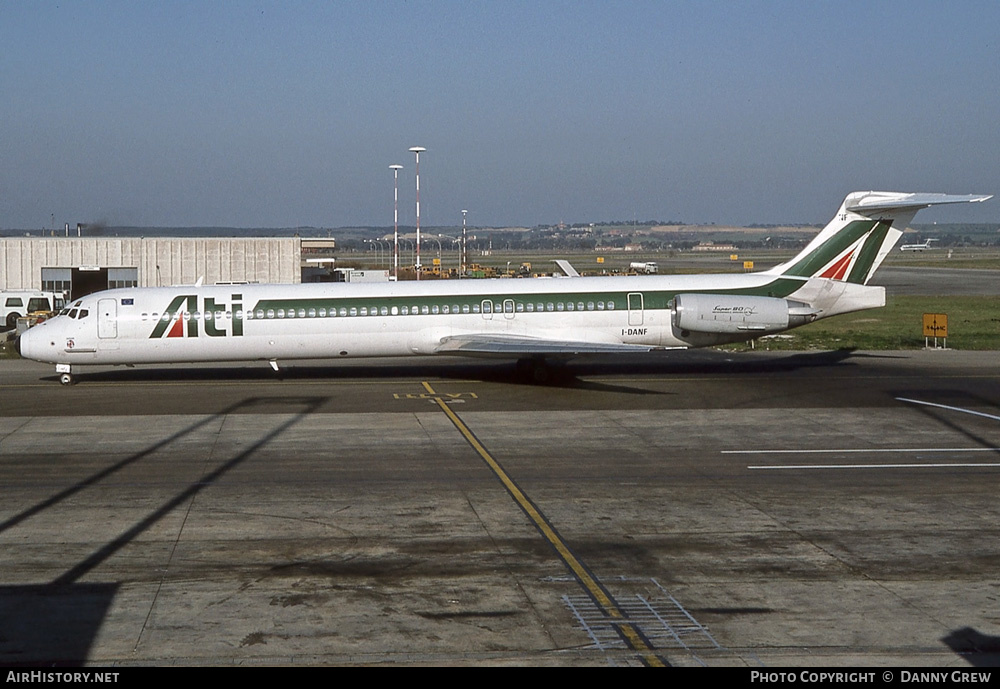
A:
[20,274,852,364]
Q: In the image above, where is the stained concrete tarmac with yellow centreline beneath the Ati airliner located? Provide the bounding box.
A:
[0,351,1000,668]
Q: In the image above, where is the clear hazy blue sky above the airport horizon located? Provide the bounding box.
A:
[0,0,1000,228]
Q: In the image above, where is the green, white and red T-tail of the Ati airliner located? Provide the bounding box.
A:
[765,191,992,285]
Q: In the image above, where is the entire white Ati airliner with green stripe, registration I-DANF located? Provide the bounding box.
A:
[17,191,991,385]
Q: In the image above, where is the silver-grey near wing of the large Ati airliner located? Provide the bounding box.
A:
[435,334,683,358]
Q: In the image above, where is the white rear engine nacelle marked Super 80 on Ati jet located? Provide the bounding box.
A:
[673,294,815,333]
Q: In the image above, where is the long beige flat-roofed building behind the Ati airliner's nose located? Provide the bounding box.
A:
[0,237,309,299]
